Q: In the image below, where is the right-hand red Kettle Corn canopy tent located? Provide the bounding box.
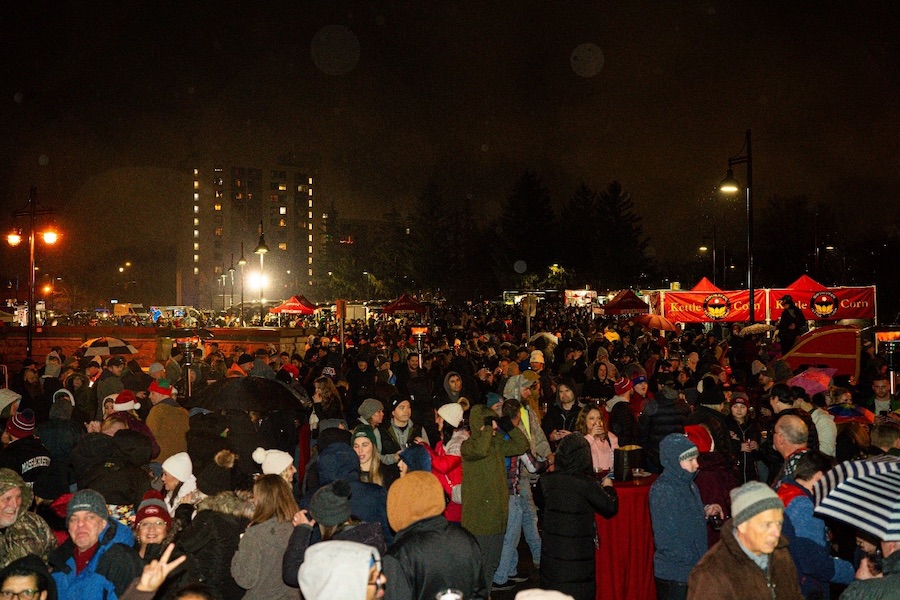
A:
[769,275,875,321]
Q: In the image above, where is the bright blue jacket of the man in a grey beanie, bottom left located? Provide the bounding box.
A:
[48,519,144,600]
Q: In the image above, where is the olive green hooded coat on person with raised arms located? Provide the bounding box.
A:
[461,404,532,536]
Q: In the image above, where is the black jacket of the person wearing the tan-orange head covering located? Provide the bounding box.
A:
[382,515,490,600]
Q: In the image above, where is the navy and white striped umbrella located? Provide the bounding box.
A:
[813,455,900,541]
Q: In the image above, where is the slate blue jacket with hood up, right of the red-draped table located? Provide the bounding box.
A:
[650,433,707,582]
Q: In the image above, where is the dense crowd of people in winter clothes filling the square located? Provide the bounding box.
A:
[0,306,900,600]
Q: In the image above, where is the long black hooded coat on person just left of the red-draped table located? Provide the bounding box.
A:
[540,436,627,600]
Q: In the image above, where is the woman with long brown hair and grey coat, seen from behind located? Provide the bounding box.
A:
[231,474,298,600]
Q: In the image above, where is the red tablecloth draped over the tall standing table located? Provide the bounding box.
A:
[594,475,656,600]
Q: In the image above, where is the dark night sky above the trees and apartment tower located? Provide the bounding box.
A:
[0,0,900,290]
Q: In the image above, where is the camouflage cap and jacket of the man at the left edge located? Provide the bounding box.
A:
[0,469,57,568]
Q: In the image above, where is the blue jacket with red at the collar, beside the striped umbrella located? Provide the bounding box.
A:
[778,478,856,600]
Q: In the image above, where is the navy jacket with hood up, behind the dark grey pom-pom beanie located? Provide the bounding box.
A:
[300,442,394,543]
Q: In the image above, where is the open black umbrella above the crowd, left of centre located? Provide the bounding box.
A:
[187,376,302,412]
